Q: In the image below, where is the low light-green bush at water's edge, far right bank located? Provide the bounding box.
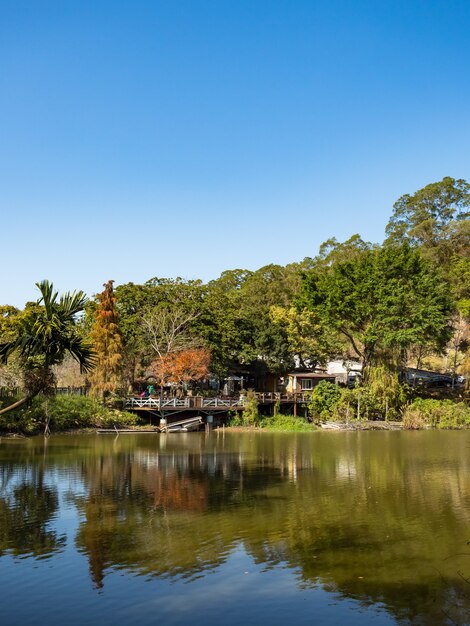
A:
[403,398,470,429]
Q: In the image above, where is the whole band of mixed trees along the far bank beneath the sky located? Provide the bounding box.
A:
[0,177,470,422]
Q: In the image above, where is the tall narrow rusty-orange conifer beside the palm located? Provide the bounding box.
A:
[90,280,123,399]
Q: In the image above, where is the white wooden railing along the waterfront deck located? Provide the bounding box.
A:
[125,393,310,413]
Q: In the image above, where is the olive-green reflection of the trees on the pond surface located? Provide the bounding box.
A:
[0,432,470,624]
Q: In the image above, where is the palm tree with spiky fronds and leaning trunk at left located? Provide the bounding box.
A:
[0,280,93,415]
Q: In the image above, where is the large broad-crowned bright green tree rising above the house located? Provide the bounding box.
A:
[298,243,453,376]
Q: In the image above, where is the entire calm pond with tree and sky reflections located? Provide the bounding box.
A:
[0,432,470,626]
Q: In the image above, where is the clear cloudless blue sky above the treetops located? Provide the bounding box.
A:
[0,0,470,306]
